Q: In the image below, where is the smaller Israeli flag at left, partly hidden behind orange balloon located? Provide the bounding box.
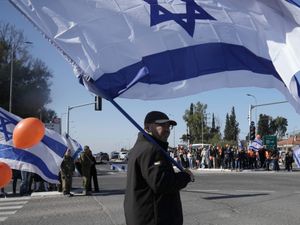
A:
[0,107,67,183]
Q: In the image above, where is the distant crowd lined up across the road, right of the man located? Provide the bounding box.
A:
[170,144,293,171]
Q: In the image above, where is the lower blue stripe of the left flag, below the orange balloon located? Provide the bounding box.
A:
[0,144,58,180]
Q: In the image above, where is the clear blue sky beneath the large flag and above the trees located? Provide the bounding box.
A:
[0,0,300,152]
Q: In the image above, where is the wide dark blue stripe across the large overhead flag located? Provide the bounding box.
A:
[94,43,282,98]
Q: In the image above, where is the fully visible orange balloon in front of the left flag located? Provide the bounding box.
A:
[13,117,45,148]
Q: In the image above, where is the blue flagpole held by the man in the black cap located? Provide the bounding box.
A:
[109,99,184,171]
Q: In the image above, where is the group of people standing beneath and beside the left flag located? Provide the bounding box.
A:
[0,146,99,197]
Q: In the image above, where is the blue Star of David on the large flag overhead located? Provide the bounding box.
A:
[144,0,216,37]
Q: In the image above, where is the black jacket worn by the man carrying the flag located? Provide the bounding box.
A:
[124,133,190,225]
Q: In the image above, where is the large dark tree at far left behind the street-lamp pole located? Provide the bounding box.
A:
[0,23,55,120]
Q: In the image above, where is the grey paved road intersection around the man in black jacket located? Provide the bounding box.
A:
[0,164,300,225]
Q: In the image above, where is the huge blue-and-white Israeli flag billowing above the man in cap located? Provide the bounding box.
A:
[10,0,300,113]
